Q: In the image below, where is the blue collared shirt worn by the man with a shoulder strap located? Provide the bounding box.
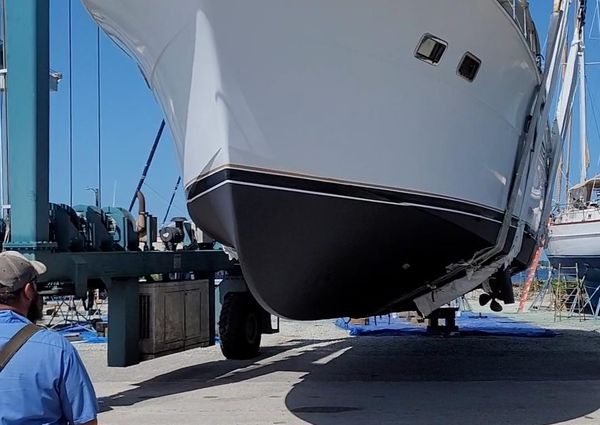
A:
[0,310,98,425]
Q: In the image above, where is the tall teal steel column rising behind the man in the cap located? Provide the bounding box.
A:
[6,0,50,250]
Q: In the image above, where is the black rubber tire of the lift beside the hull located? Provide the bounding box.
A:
[219,292,261,360]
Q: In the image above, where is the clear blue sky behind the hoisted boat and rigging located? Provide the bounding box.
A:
[50,0,600,220]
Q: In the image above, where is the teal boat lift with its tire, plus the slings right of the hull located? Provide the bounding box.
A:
[0,0,585,352]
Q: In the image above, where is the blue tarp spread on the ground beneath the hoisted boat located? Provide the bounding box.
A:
[335,313,556,337]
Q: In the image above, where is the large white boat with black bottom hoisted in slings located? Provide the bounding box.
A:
[83,0,571,320]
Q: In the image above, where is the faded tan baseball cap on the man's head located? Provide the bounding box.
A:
[0,251,46,292]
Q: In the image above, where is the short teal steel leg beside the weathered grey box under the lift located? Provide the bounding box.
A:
[108,278,140,367]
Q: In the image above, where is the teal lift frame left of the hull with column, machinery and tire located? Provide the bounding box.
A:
[1,0,277,367]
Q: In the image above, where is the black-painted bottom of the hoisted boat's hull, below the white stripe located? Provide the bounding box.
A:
[188,177,535,320]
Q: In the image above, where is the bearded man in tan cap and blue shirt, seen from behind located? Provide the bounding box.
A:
[0,251,97,425]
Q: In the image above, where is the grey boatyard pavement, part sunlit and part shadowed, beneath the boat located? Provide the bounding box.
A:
[76,304,600,425]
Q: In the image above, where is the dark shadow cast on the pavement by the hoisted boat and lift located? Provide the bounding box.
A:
[100,331,600,425]
